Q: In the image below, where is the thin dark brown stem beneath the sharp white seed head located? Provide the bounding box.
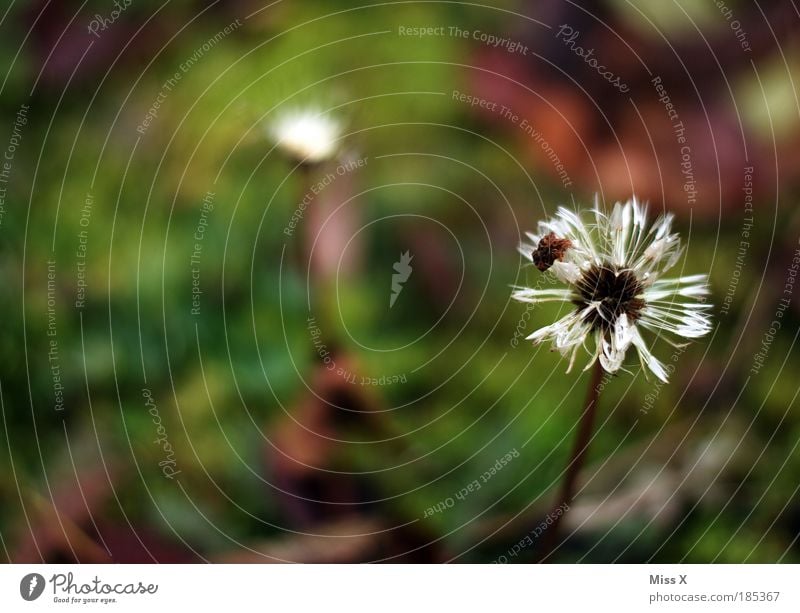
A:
[539,360,603,562]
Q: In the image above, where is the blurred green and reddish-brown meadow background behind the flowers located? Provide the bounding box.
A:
[0,0,800,562]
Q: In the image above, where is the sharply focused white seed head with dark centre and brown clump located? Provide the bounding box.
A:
[513,197,711,382]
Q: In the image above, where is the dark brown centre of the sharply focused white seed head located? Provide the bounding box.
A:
[572,264,645,329]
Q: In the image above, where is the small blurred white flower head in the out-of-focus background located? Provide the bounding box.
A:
[269,109,342,164]
